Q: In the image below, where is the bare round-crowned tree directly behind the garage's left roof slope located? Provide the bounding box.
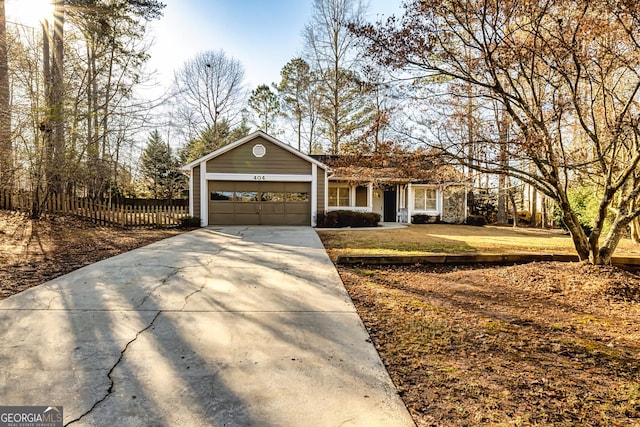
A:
[174,50,247,146]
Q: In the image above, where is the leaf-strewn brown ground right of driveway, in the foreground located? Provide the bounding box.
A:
[339,263,640,427]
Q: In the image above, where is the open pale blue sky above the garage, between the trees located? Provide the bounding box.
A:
[150,0,402,89]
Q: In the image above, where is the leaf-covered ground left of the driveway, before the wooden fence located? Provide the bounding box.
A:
[0,211,182,299]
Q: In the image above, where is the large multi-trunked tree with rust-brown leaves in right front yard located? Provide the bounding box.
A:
[358,0,640,264]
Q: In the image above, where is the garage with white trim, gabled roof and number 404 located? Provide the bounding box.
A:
[183,131,327,226]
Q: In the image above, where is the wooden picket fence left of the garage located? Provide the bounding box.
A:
[0,191,189,228]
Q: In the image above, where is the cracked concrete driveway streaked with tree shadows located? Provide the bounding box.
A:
[0,227,414,427]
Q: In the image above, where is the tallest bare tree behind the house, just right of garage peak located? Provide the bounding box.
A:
[303,0,366,154]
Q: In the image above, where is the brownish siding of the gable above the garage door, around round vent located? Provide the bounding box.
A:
[207,137,311,175]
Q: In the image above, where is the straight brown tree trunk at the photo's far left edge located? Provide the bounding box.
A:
[0,0,9,190]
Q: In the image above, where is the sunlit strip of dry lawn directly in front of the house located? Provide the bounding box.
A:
[318,224,640,259]
